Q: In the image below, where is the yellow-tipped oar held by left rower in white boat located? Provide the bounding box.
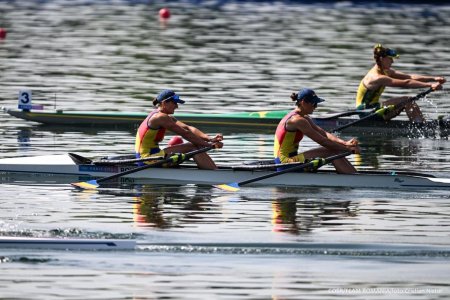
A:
[71,146,214,189]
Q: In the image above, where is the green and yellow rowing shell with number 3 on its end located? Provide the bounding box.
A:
[3,108,450,137]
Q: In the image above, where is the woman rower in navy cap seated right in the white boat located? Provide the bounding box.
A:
[274,89,360,173]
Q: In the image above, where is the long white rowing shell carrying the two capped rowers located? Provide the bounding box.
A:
[0,154,450,189]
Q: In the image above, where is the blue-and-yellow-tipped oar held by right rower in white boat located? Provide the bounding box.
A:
[214,151,352,192]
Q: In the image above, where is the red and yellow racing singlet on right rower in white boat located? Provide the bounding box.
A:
[273,110,305,163]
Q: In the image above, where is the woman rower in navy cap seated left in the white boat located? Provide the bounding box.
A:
[135,90,223,170]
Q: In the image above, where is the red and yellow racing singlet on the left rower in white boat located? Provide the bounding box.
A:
[134,109,166,158]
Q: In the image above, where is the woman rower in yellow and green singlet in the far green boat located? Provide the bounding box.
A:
[356,44,446,122]
